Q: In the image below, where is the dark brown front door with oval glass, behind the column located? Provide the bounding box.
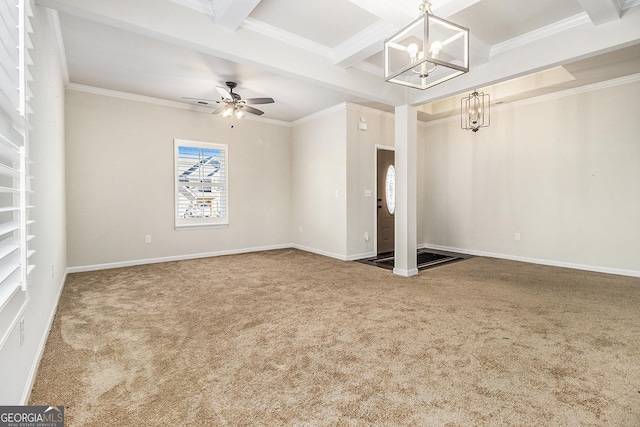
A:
[377,149,396,254]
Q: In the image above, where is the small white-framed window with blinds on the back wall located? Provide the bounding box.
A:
[174,139,229,228]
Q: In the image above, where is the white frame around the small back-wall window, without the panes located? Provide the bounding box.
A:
[173,138,229,230]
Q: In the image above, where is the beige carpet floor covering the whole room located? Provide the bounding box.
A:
[30,249,640,426]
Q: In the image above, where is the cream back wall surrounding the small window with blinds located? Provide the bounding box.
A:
[66,90,291,271]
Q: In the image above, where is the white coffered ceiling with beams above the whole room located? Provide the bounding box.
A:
[36,0,640,122]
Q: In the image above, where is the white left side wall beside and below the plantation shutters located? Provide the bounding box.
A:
[0,7,67,405]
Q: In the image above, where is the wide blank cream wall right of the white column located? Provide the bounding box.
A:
[419,81,640,275]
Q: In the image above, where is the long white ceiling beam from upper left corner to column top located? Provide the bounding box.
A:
[36,0,407,106]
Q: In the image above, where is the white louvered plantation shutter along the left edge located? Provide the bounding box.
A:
[0,0,33,311]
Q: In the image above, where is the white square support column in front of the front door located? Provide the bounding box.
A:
[393,105,418,277]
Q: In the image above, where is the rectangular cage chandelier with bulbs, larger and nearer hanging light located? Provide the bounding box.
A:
[384,0,469,90]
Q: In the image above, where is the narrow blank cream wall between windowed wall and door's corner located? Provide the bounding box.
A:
[290,105,347,259]
